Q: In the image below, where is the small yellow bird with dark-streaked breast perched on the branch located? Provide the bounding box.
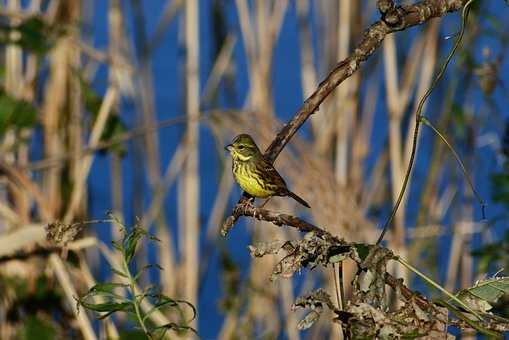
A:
[225,133,311,208]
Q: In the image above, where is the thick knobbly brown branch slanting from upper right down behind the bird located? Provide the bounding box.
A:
[222,0,466,235]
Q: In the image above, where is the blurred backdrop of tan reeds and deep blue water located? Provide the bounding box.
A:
[0,0,509,340]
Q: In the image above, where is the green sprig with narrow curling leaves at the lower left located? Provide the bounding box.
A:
[77,220,196,339]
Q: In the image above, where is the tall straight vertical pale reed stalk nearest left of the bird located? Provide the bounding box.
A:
[179,0,200,325]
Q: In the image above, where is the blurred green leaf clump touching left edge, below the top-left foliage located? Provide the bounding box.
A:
[0,91,37,135]
